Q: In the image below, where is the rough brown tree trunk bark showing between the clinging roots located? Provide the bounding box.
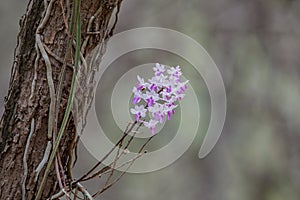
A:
[0,0,121,199]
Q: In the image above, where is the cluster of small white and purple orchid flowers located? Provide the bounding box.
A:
[130,63,188,134]
